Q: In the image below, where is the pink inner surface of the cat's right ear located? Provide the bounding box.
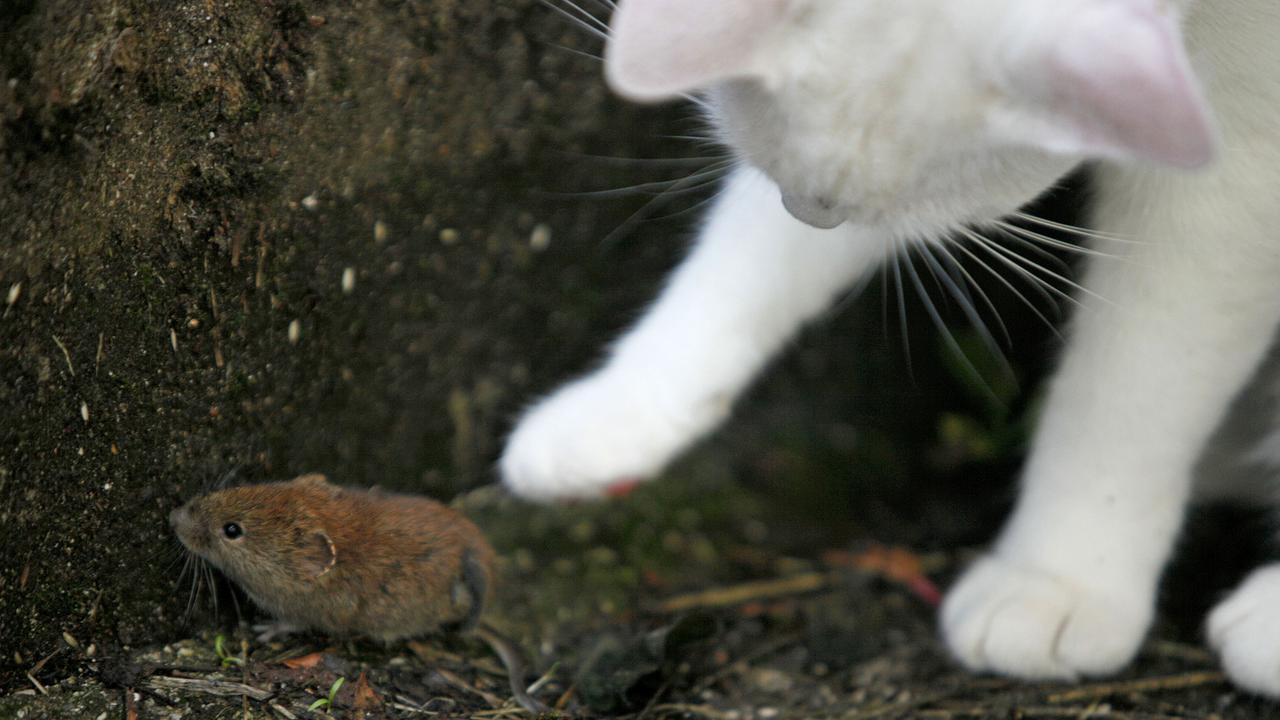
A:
[1046,1,1215,168]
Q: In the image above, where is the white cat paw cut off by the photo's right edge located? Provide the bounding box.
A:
[1208,565,1280,697]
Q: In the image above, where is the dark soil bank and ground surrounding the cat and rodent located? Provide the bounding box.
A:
[0,0,1276,719]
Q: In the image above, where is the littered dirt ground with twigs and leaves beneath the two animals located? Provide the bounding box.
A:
[0,471,1276,720]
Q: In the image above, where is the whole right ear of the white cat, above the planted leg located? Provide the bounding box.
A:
[1001,0,1216,168]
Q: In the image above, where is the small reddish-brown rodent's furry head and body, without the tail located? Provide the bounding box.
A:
[169,475,494,642]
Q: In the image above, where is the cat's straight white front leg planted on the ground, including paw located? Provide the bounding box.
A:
[942,163,1280,679]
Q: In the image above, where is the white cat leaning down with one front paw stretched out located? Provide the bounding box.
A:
[500,0,1280,696]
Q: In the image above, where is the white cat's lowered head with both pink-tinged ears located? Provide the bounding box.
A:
[605,0,1215,227]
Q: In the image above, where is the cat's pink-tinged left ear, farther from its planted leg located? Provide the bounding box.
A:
[604,0,791,101]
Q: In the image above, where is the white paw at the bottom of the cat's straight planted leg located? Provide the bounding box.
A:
[942,556,1152,680]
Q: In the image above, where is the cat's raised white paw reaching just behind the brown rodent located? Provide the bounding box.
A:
[499,373,718,501]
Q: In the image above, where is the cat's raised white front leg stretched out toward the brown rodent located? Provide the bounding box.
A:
[500,169,888,500]
